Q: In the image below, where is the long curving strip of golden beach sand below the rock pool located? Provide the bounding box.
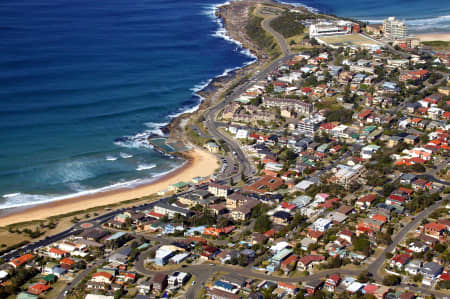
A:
[0,149,219,226]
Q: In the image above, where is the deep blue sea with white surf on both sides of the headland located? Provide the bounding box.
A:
[0,0,450,208]
